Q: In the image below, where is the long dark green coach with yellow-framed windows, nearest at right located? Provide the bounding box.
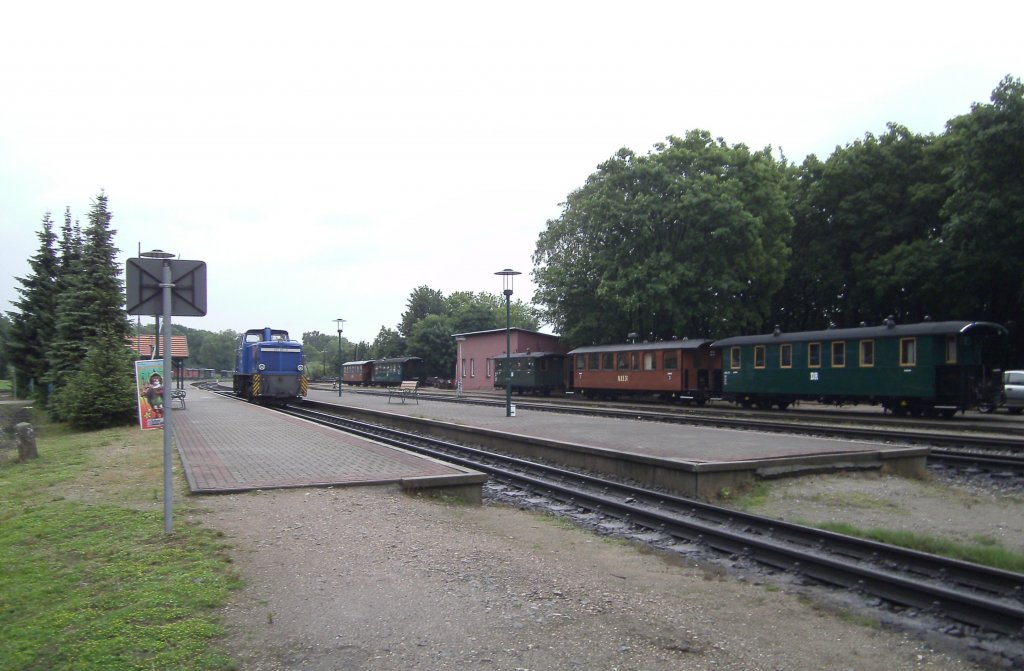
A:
[713,318,1007,416]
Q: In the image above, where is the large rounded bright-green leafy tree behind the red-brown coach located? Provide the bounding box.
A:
[534,131,793,343]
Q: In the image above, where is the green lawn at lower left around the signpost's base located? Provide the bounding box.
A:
[0,416,239,671]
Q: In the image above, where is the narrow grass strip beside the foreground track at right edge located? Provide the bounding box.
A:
[817,522,1024,573]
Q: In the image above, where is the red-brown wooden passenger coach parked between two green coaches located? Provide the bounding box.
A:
[569,339,722,404]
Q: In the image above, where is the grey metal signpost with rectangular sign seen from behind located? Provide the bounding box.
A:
[125,255,206,534]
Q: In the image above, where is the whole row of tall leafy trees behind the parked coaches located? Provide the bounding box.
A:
[534,76,1024,365]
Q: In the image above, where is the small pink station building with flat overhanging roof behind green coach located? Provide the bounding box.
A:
[452,328,568,391]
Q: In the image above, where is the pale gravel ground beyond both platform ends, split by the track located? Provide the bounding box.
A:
[196,469,1024,671]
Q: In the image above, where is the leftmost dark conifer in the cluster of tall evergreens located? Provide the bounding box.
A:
[6,212,58,400]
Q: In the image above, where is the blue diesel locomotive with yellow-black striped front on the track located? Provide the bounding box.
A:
[233,327,308,406]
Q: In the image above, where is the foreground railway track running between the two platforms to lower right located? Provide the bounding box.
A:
[272,399,1024,639]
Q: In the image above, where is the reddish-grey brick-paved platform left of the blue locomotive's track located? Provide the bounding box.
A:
[172,389,486,500]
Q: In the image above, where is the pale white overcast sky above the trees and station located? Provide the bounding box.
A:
[0,0,1024,341]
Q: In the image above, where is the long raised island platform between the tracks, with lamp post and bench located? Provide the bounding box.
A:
[307,387,929,499]
